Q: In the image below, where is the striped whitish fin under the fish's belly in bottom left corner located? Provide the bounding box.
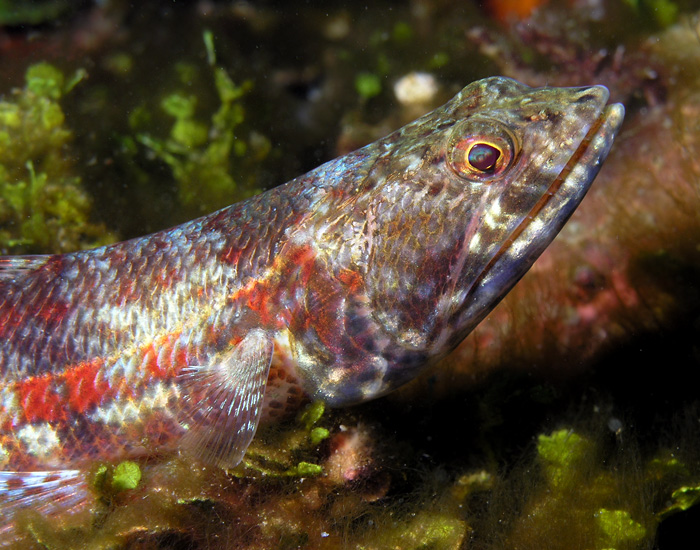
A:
[0,470,90,548]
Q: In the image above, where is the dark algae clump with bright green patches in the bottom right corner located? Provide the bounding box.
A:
[484,429,700,550]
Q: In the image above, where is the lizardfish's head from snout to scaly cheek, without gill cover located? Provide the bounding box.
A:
[366,77,624,386]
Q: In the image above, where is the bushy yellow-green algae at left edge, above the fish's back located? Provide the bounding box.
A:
[0,63,114,254]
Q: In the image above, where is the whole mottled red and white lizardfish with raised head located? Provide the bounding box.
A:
[0,78,624,536]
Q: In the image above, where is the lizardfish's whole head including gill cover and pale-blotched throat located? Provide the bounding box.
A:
[294,77,624,405]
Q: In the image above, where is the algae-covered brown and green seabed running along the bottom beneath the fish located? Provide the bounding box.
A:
[6,418,700,550]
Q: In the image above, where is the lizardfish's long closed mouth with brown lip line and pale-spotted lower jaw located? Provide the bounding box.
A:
[460,97,625,330]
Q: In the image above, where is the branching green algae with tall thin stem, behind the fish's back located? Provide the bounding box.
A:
[130,32,270,215]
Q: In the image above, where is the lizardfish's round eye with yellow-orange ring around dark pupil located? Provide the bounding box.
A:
[448,118,519,183]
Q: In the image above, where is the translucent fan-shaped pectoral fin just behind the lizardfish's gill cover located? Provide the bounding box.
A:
[180,329,273,468]
